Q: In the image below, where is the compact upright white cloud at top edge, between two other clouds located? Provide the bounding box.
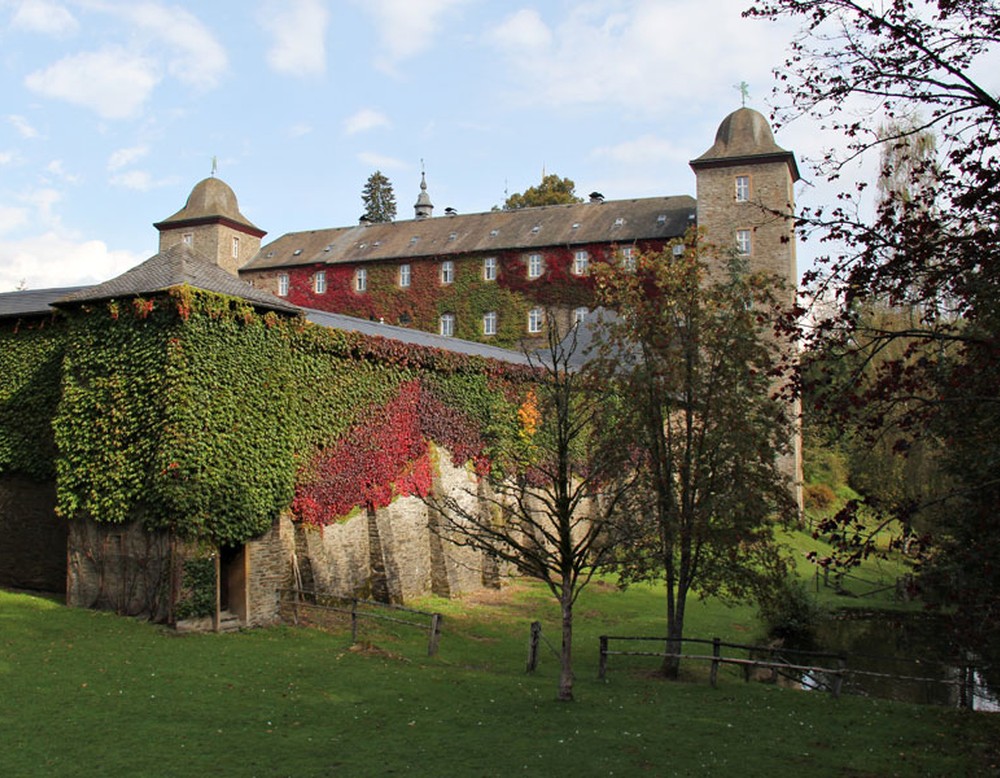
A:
[258,0,329,76]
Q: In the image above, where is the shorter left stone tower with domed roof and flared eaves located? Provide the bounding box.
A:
[153,176,267,275]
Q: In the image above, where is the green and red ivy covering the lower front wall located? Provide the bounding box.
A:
[0,287,532,545]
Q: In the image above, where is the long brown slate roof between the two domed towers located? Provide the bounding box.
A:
[240,195,695,272]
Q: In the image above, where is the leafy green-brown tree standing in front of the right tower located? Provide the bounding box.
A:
[595,232,798,676]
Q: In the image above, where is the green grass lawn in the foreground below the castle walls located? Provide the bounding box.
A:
[0,584,1000,776]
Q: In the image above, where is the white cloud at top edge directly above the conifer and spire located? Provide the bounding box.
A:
[363,0,467,71]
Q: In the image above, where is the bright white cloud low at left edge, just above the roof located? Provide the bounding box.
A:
[0,233,145,292]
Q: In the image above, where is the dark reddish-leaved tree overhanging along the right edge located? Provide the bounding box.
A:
[748,0,1000,643]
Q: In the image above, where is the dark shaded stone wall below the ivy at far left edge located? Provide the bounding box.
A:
[0,475,67,592]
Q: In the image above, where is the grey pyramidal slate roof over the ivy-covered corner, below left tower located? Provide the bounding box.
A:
[57,243,300,313]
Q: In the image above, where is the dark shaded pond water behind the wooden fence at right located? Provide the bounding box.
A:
[803,610,1000,712]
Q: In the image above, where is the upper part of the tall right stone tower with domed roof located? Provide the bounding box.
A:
[691,107,799,294]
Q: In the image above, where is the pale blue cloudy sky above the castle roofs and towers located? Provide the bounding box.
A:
[0,0,840,292]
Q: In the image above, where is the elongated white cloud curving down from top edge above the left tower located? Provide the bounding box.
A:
[117,2,229,89]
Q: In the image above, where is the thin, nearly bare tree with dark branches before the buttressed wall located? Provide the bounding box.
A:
[431,319,634,701]
